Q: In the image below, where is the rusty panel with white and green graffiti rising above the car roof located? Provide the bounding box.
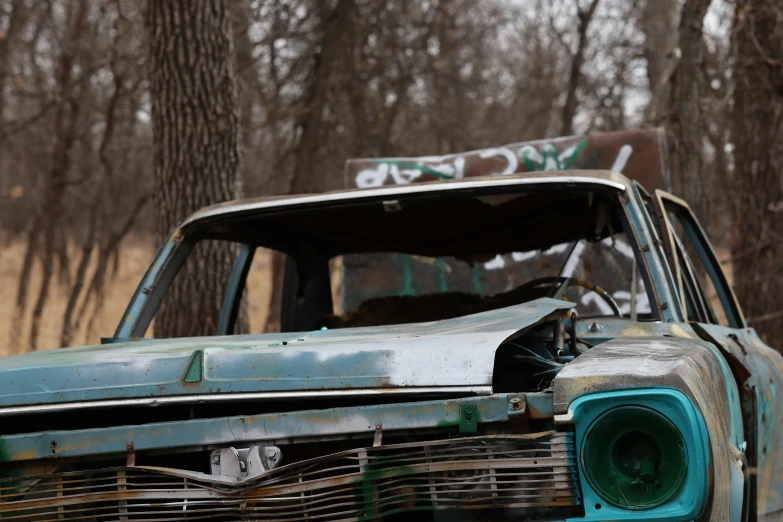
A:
[345,129,670,190]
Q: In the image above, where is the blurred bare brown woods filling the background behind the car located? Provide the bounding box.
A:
[0,0,783,352]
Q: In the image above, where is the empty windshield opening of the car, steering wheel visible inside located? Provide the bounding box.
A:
[139,186,653,334]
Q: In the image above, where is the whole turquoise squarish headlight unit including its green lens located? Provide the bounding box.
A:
[555,388,710,522]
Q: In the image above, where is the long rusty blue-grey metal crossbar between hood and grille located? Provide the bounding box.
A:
[0,392,552,465]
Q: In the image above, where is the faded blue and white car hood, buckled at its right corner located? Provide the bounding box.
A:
[0,299,573,408]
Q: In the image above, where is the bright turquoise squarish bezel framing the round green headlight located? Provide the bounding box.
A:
[569,388,710,521]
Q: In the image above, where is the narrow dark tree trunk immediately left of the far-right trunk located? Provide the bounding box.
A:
[671,0,711,231]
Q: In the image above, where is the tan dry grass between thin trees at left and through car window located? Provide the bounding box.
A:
[0,240,270,356]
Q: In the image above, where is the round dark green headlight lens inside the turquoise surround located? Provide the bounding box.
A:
[582,406,688,510]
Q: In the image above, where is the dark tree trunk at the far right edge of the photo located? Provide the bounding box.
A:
[732,0,783,351]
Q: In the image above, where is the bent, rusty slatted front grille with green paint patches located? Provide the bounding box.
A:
[0,432,579,522]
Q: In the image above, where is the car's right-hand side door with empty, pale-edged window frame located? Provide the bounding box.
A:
[655,191,783,520]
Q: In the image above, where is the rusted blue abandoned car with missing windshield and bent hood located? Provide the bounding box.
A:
[0,161,783,521]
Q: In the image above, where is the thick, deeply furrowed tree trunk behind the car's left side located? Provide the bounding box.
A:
[147,0,246,337]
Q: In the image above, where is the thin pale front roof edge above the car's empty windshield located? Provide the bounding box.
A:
[180,170,631,228]
